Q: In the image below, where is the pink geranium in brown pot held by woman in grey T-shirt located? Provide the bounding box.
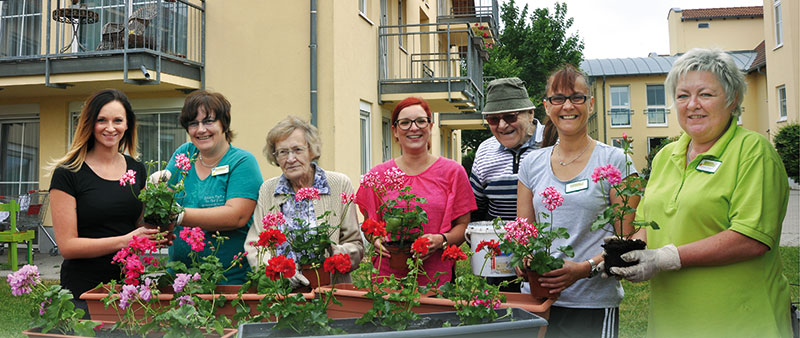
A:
[494,187,574,298]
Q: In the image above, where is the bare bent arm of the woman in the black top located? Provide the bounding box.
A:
[50,189,158,259]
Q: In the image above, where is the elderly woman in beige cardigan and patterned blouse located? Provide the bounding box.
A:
[244,116,364,287]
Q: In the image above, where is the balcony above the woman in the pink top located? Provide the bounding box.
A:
[378,23,491,112]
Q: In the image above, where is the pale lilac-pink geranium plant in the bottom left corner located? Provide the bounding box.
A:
[7,265,102,337]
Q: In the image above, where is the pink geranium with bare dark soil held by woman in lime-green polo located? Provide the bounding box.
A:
[591,133,658,276]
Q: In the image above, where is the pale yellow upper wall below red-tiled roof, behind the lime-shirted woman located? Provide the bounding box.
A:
[667,8,769,55]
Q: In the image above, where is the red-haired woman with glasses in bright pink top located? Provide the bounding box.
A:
[356,97,477,285]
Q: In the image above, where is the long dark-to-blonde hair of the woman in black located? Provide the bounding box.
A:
[47,89,137,172]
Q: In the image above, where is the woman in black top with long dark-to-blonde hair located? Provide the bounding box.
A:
[50,89,164,315]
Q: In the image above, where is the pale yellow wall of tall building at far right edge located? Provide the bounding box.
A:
[764,0,800,137]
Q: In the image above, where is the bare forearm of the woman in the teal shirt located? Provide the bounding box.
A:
[180,197,260,231]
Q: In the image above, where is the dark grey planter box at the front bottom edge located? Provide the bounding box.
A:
[239,308,547,338]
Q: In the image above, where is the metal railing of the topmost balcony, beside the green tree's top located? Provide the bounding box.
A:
[438,0,500,36]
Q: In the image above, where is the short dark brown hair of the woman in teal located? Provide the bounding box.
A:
[178,90,234,143]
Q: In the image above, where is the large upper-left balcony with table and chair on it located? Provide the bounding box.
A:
[0,0,205,96]
